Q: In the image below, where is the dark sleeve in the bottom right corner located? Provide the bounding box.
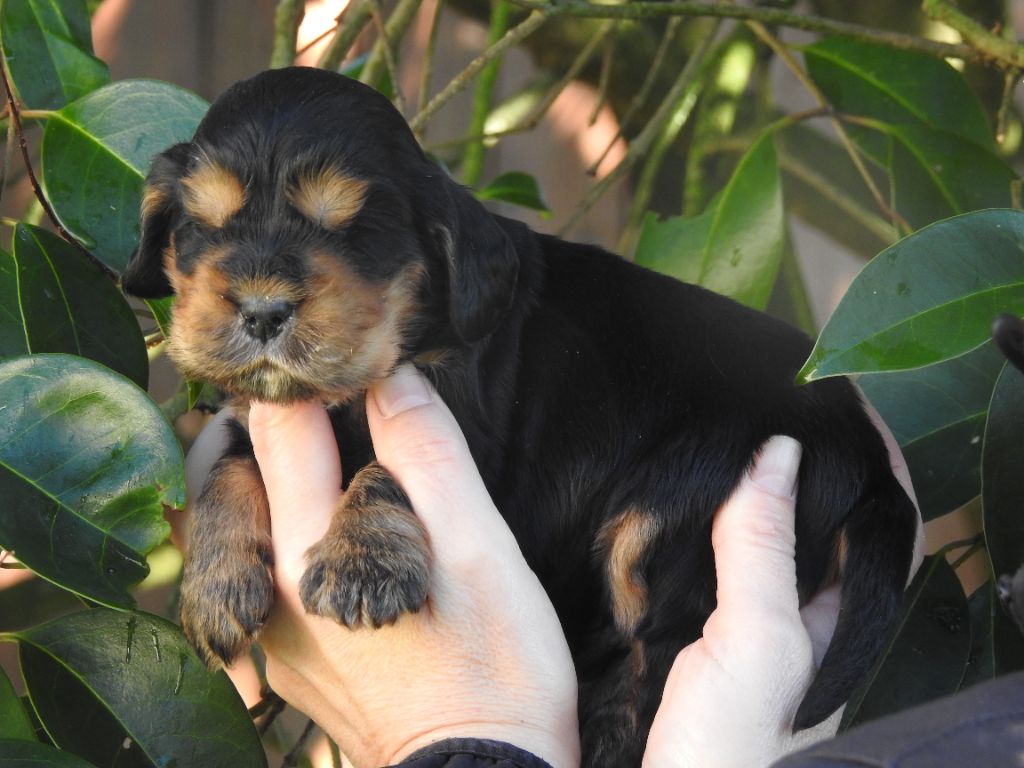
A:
[774,674,1024,768]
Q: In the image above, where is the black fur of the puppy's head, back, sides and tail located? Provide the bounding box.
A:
[124,69,916,768]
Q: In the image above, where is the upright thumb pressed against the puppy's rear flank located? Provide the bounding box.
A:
[712,436,801,622]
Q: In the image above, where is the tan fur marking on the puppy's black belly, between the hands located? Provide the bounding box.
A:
[598,509,662,634]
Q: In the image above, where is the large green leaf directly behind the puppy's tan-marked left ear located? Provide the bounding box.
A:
[41,80,207,271]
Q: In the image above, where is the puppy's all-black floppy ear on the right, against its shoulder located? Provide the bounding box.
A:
[430,179,519,343]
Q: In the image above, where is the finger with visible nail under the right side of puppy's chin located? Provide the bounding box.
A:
[367,365,516,554]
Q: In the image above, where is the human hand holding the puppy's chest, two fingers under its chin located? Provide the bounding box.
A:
[249,367,580,768]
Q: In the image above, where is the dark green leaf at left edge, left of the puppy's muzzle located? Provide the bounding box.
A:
[0,223,150,387]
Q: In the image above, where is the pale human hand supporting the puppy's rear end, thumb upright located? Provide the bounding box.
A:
[643,412,924,768]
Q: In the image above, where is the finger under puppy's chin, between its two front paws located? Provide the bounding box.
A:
[249,402,341,573]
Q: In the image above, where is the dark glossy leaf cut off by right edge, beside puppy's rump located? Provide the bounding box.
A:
[981,365,1024,577]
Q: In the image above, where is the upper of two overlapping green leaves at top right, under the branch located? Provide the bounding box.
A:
[804,37,995,154]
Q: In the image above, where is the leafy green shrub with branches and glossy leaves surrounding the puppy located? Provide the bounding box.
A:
[0,0,1024,768]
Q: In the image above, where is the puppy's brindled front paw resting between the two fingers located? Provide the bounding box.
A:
[300,463,429,628]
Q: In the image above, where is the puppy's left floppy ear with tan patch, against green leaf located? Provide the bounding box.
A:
[121,143,193,299]
